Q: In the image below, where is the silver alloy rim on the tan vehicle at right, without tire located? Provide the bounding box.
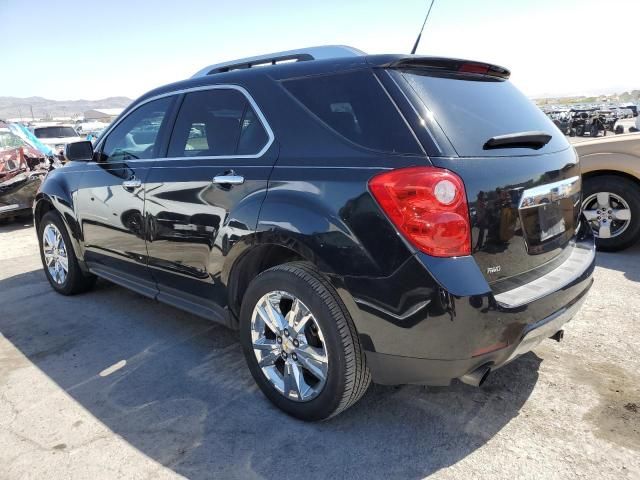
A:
[582,192,631,238]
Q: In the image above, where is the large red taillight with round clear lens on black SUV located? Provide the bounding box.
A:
[369,167,471,257]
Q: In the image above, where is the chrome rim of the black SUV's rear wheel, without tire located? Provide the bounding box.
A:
[251,291,329,402]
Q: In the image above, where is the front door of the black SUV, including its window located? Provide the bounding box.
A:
[76,97,174,296]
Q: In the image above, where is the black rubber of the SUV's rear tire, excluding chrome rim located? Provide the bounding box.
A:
[240,262,371,421]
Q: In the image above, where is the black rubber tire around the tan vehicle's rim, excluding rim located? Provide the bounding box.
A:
[582,175,640,252]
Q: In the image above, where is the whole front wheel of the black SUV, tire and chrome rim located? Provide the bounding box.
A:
[38,210,96,295]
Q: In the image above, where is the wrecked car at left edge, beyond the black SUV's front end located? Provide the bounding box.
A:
[0,123,51,219]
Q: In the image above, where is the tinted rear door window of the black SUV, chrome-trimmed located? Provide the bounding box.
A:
[168,89,268,157]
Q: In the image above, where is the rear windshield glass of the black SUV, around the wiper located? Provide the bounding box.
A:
[400,70,569,157]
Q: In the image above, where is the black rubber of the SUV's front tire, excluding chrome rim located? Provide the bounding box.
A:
[38,210,96,295]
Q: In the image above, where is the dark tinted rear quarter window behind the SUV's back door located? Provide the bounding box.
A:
[283,70,422,154]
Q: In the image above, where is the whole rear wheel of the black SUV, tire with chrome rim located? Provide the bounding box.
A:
[240,262,371,421]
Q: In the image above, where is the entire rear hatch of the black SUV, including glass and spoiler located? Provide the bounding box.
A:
[389,59,580,293]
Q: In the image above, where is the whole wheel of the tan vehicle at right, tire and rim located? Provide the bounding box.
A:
[582,175,640,252]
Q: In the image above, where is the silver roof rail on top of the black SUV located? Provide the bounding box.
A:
[191,45,366,78]
